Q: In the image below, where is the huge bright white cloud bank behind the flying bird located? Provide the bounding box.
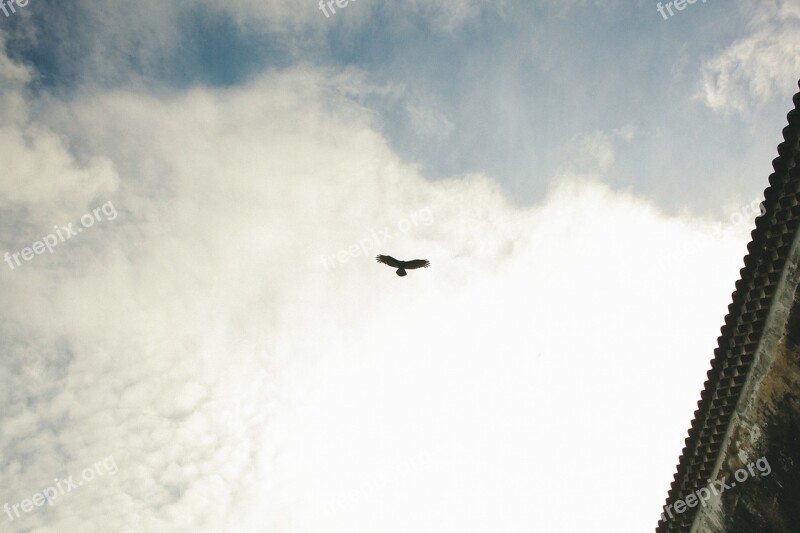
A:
[0,51,746,533]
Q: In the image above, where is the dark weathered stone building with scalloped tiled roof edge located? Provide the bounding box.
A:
[656,80,800,533]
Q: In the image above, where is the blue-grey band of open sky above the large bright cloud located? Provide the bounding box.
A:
[9,2,794,208]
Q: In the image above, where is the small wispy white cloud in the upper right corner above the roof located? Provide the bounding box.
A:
[698,0,800,113]
